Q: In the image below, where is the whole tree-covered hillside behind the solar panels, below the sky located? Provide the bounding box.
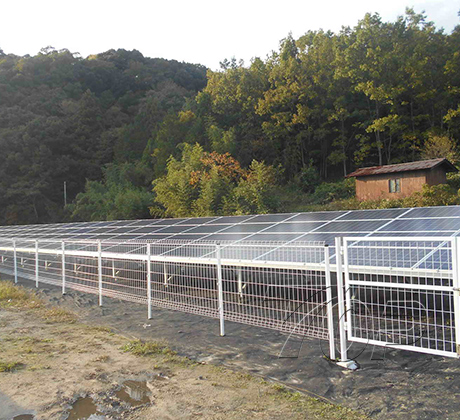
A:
[0,9,460,224]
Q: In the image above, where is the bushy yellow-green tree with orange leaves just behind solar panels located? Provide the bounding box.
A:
[151,144,277,217]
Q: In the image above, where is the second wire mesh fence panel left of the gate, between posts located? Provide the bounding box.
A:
[151,262,218,317]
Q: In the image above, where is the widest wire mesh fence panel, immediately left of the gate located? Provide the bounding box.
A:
[223,266,329,339]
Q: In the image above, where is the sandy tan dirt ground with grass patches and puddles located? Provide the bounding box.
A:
[0,282,365,420]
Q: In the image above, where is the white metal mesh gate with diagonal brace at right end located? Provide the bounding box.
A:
[344,238,458,356]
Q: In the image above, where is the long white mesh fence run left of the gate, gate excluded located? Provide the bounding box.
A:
[0,239,335,359]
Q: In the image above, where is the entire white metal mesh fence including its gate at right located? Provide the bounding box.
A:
[0,237,460,360]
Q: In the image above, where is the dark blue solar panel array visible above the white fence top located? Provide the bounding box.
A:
[0,206,460,245]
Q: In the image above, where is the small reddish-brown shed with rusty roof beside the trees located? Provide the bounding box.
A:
[347,158,458,200]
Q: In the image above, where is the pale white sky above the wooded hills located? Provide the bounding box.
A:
[0,0,460,70]
